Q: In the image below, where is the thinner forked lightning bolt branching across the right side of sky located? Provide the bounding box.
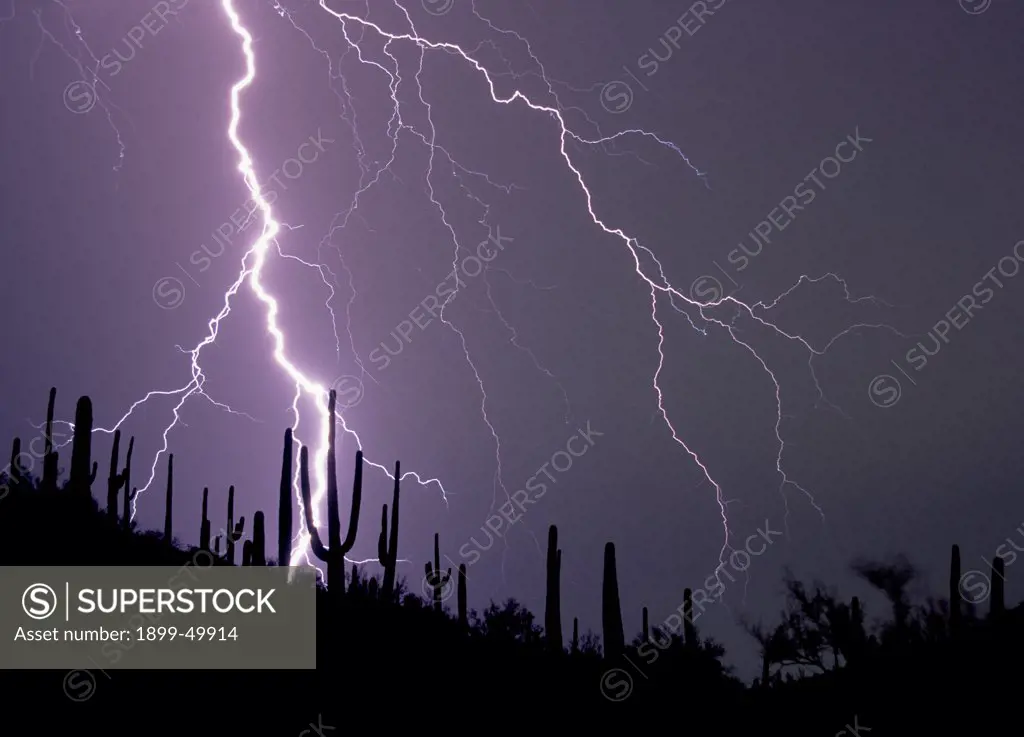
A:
[293,0,896,575]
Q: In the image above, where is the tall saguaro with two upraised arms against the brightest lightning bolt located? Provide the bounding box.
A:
[299,389,362,603]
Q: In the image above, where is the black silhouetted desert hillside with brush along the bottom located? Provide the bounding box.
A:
[0,388,1024,737]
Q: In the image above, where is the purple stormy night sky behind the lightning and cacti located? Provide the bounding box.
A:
[0,0,1024,676]
